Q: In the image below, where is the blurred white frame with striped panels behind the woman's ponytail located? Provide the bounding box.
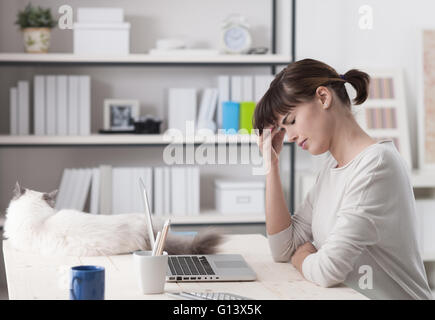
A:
[353,68,412,171]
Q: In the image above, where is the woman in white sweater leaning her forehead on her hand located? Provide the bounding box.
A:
[254,59,432,299]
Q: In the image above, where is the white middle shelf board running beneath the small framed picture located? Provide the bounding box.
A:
[0,134,257,146]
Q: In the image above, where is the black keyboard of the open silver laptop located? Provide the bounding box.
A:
[168,256,215,276]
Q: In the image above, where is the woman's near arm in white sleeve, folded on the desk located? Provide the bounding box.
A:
[295,156,384,287]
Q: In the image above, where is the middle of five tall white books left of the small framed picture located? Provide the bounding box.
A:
[56,75,68,136]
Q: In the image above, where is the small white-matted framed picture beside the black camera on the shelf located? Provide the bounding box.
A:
[104,99,139,131]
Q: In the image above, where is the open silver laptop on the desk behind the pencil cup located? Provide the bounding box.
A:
[139,178,257,282]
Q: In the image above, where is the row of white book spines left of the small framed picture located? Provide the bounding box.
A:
[10,75,91,136]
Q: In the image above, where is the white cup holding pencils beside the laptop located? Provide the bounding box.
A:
[133,251,168,294]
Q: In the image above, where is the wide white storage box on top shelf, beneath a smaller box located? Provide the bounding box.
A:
[74,22,130,55]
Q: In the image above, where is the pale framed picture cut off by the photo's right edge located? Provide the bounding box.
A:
[418,29,435,171]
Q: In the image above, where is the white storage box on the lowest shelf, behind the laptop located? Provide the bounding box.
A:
[215,180,265,214]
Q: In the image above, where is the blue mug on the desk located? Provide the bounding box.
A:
[69,266,105,300]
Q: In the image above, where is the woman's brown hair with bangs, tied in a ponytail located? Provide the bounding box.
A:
[254,59,370,134]
